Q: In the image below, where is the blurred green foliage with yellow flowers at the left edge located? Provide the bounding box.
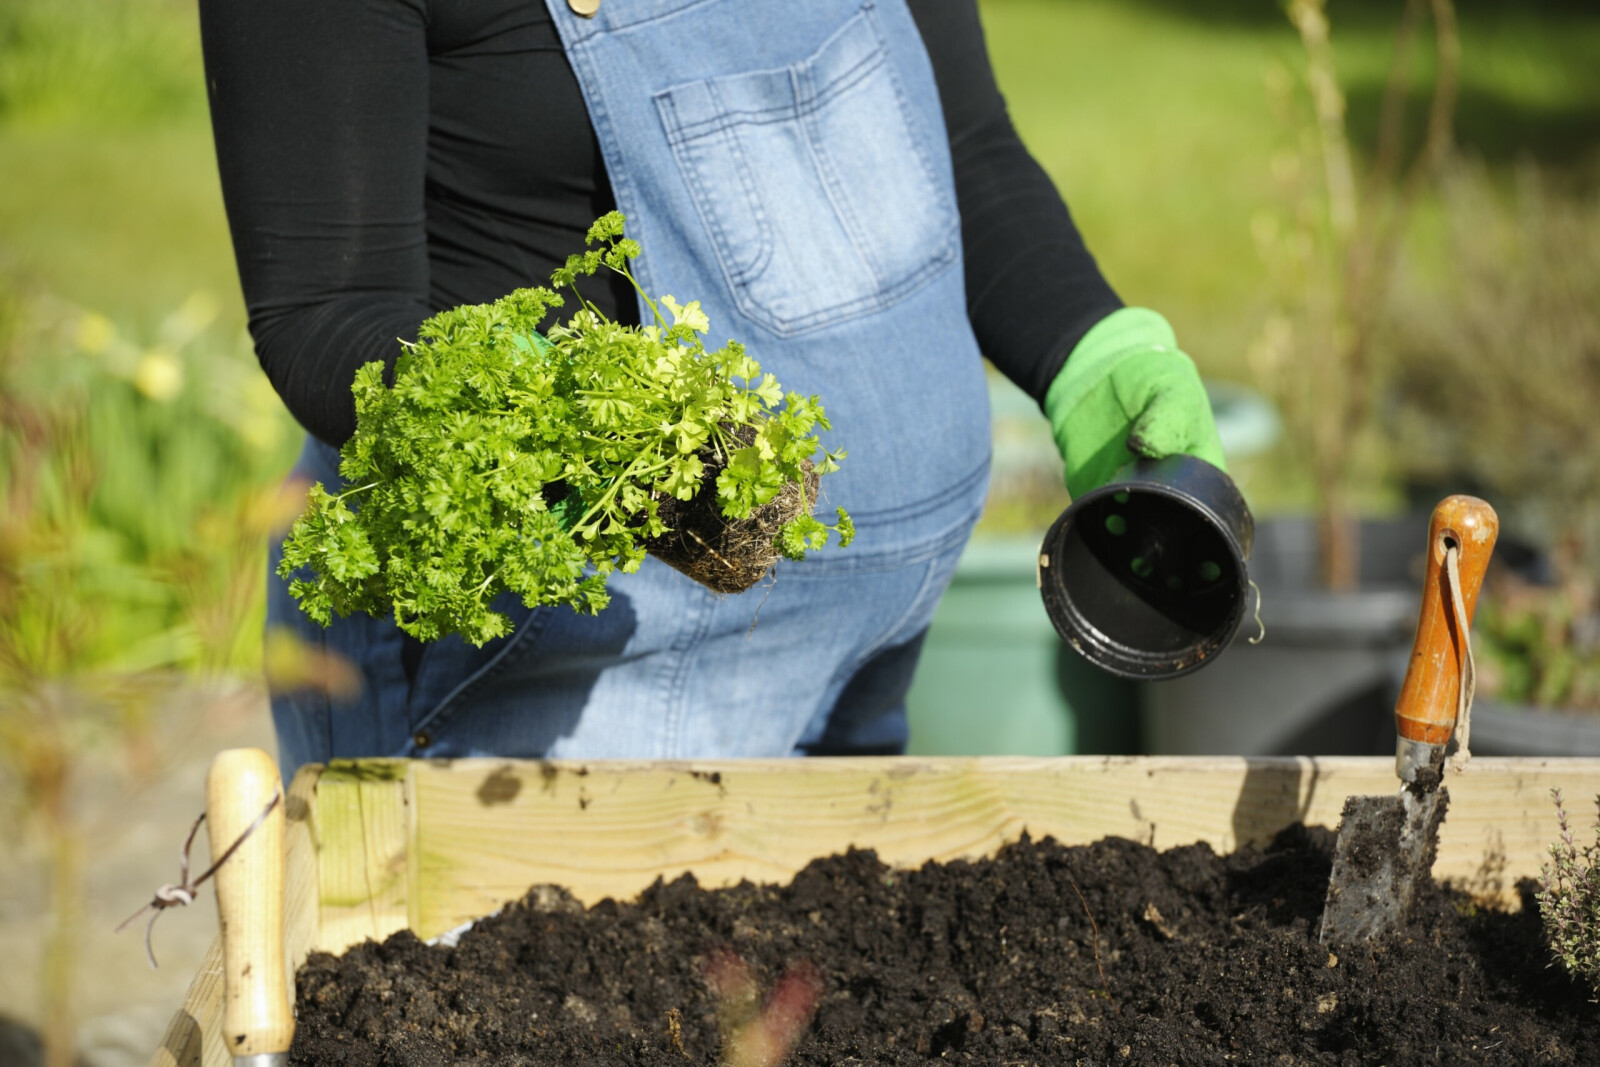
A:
[0,286,298,684]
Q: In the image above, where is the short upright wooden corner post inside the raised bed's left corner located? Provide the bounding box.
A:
[310,760,416,952]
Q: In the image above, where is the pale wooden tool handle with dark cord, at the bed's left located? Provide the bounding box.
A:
[205,749,294,1057]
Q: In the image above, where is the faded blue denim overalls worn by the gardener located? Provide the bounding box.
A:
[269,0,989,773]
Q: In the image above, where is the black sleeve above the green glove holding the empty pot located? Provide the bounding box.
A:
[909,0,1122,403]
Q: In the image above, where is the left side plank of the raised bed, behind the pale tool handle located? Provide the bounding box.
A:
[150,766,322,1067]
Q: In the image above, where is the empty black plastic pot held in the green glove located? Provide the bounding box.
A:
[1038,456,1254,680]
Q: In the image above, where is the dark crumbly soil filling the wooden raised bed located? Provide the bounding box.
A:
[291,827,1600,1067]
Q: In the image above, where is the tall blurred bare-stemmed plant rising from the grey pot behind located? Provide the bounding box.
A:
[1250,0,1461,590]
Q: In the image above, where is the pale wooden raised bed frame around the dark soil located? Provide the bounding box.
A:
[152,757,1600,1067]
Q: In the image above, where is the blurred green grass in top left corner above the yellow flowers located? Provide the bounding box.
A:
[0,0,233,328]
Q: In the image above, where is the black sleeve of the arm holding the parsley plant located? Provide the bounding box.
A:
[200,0,429,445]
